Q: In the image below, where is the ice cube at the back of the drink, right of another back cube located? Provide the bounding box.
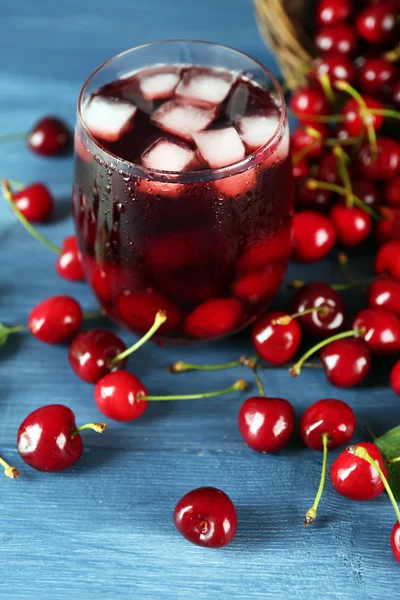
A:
[176,67,237,105]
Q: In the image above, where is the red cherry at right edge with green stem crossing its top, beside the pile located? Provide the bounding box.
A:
[357,136,400,181]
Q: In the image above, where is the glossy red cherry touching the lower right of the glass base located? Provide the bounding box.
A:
[251,311,301,365]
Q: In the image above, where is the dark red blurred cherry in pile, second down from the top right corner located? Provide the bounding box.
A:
[358,57,397,98]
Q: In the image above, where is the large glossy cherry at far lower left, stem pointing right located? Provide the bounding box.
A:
[17,404,83,471]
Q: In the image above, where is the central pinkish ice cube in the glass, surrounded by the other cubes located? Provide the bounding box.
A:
[151,100,216,140]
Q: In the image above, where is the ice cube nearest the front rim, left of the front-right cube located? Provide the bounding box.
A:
[142,138,196,171]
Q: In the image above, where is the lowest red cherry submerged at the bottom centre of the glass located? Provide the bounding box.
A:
[185,298,243,338]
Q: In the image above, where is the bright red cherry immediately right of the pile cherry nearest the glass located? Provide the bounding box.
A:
[329,203,372,248]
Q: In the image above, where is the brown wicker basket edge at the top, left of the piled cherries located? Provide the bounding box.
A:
[254,0,317,87]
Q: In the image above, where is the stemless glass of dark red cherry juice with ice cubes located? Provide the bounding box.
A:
[73,40,293,343]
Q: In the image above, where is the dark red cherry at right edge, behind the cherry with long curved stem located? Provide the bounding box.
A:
[352,308,400,356]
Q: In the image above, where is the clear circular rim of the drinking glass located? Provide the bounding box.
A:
[77,38,287,182]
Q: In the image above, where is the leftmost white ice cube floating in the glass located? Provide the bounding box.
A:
[82,96,137,142]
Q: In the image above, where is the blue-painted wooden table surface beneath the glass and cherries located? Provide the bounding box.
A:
[0,0,400,600]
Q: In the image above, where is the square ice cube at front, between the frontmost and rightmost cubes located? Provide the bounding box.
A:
[193,127,246,169]
